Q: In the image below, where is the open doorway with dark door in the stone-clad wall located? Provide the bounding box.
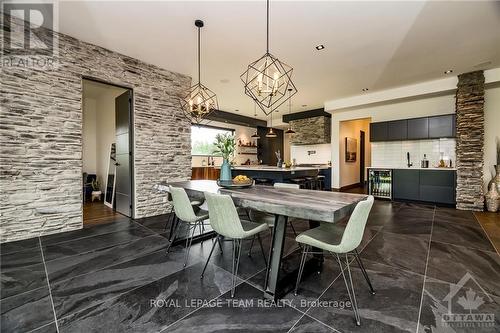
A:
[82,79,134,226]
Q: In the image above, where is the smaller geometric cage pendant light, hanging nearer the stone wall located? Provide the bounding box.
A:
[180,20,219,124]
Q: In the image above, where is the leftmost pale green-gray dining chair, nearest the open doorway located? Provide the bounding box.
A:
[167,186,208,267]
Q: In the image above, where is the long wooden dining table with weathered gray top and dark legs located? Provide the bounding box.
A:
[155,180,367,300]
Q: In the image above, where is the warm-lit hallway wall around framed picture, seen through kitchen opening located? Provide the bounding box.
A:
[335,118,371,187]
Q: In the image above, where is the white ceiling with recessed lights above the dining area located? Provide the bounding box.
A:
[59,1,500,118]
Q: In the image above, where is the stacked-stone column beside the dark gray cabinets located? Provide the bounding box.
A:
[456,71,484,211]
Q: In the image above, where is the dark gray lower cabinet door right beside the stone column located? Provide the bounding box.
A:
[420,170,456,204]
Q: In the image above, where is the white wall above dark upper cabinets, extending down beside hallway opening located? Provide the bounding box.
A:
[327,93,455,188]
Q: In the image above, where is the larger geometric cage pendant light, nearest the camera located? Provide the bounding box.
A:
[240,0,297,115]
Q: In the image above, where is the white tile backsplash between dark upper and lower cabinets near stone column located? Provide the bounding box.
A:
[371,139,456,168]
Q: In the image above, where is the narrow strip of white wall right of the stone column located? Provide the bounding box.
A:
[483,85,500,190]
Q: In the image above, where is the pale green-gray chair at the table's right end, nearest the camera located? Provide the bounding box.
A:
[295,195,375,326]
